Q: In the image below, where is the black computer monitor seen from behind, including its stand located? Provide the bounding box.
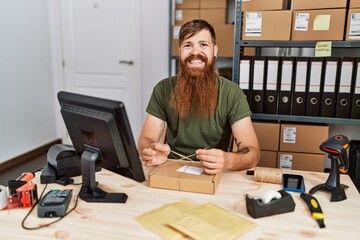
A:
[58,91,145,203]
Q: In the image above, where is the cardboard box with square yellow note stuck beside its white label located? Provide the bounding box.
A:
[291,9,346,40]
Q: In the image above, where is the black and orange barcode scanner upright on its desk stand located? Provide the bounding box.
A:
[309,135,349,202]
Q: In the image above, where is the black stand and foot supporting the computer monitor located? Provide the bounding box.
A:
[79,146,128,203]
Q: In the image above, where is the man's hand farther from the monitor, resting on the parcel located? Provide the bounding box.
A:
[196,148,226,174]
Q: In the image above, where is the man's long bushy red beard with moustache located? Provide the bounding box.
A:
[170,55,218,118]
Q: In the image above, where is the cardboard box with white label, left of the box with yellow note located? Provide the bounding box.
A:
[242,10,292,40]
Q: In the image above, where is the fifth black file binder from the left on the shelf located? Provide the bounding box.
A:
[291,57,309,116]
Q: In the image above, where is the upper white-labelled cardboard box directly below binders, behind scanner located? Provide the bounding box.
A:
[279,123,329,154]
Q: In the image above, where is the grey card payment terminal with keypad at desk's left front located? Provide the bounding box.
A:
[38,189,72,218]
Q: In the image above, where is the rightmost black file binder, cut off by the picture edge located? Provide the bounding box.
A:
[350,58,360,119]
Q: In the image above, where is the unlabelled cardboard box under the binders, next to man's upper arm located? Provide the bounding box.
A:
[253,122,280,151]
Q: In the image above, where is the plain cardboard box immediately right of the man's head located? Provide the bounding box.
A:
[214,24,234,57]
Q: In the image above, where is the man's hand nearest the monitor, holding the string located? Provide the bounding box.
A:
[140,143,170,167]
